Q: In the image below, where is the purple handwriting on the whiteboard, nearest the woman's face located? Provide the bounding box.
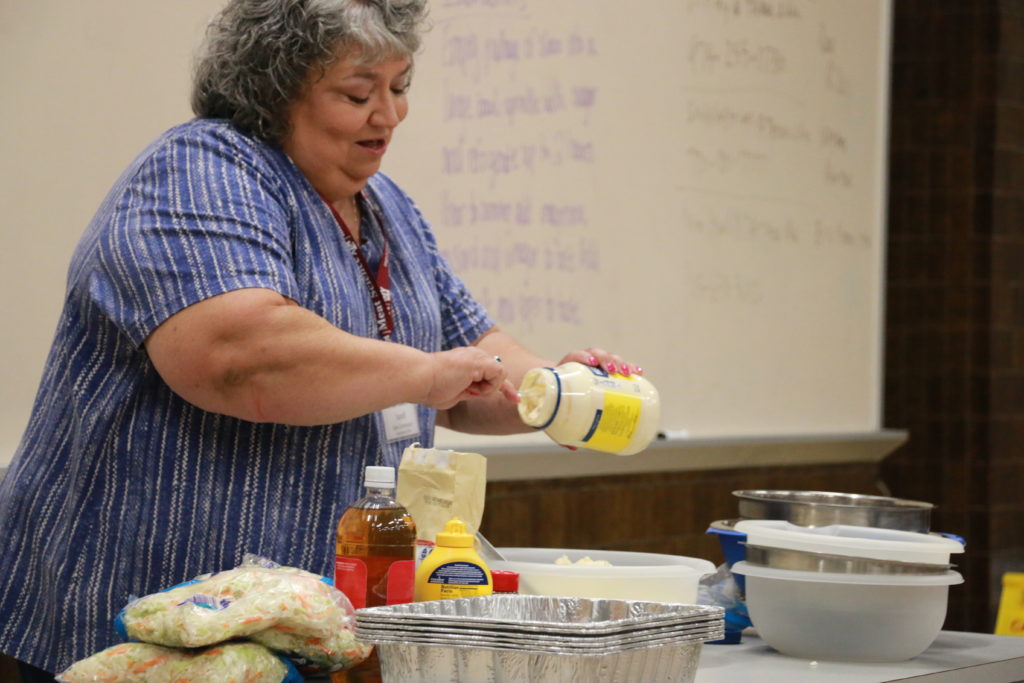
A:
[421,6,602,331]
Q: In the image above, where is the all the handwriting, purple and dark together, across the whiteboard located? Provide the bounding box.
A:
[411,0,880,334]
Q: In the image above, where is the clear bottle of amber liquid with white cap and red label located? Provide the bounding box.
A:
[331,467,416,683]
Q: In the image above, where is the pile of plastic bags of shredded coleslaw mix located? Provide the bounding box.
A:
[57,555,372,683]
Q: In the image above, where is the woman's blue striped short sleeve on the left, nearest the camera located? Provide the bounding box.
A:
[88,126,297,344]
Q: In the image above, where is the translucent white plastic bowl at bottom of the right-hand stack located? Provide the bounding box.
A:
[732,562,964,661]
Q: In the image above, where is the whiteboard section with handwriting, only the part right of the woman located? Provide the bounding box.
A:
[385,0,890,442]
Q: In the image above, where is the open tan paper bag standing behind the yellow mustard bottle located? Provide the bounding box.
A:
[396,443,487,544]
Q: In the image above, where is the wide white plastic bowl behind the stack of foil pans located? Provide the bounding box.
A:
[487,548,715,603]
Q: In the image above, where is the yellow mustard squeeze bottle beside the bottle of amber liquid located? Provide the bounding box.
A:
[414,517,494,602]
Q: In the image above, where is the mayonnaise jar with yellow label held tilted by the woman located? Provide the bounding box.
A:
[519,362,662,456]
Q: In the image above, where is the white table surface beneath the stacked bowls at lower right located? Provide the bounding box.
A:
[696,630,1024,683]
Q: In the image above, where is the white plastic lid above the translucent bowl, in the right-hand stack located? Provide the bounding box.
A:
[735,519,964,564]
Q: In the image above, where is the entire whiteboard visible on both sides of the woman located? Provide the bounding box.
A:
[0,0,890,465]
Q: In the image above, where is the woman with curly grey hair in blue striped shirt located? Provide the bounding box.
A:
[0,0,634,672]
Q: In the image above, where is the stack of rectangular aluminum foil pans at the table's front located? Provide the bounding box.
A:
[355,595,724,683]
